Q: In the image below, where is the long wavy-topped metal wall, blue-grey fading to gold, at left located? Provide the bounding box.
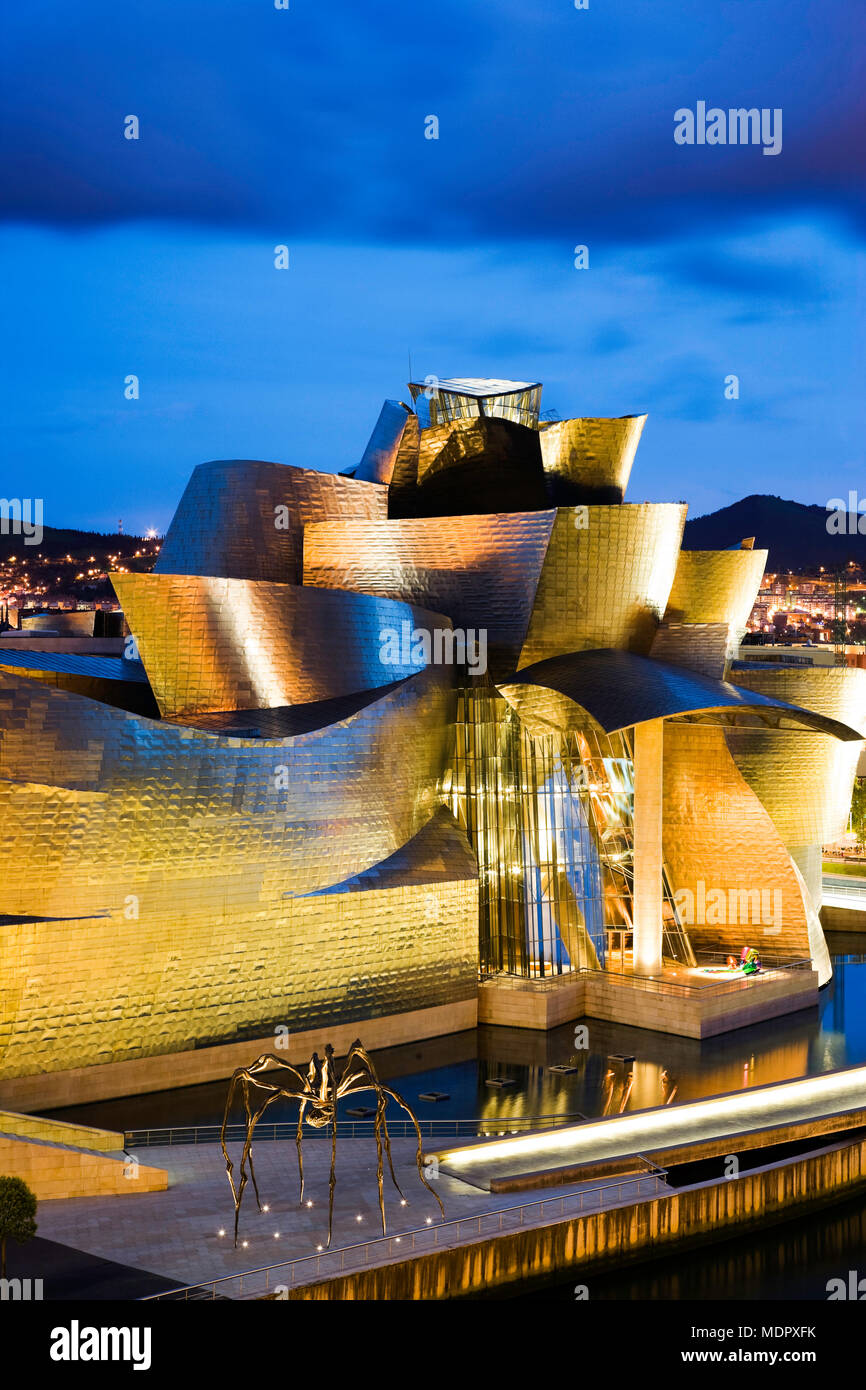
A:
[0,667,455,916]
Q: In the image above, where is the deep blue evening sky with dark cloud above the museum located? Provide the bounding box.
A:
[0,0,866,530]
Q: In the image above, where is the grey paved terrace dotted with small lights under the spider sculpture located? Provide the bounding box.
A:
[38,1134,663,1298]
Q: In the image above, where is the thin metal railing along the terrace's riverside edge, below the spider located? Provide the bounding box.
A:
[140,1168,667,1302]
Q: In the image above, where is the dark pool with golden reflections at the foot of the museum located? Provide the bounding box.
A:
[53,937,866,1129]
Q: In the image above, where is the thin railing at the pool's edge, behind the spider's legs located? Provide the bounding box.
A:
[125,1113,587,1150]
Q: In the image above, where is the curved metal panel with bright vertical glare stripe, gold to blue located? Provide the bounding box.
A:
[114,574,450,716]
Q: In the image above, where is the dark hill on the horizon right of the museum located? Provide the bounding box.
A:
[683,492,866,574]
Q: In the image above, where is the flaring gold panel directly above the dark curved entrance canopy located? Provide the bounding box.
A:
[517,502,685,669]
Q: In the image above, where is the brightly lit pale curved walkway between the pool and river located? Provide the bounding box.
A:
[438,1066,866,1188]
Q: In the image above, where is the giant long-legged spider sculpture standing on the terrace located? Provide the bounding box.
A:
[220,1038,445,1245]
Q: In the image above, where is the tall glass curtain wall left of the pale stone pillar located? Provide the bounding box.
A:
[450,682,694,979]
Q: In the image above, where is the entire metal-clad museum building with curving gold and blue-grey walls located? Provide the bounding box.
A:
[0,378,866,1077]
